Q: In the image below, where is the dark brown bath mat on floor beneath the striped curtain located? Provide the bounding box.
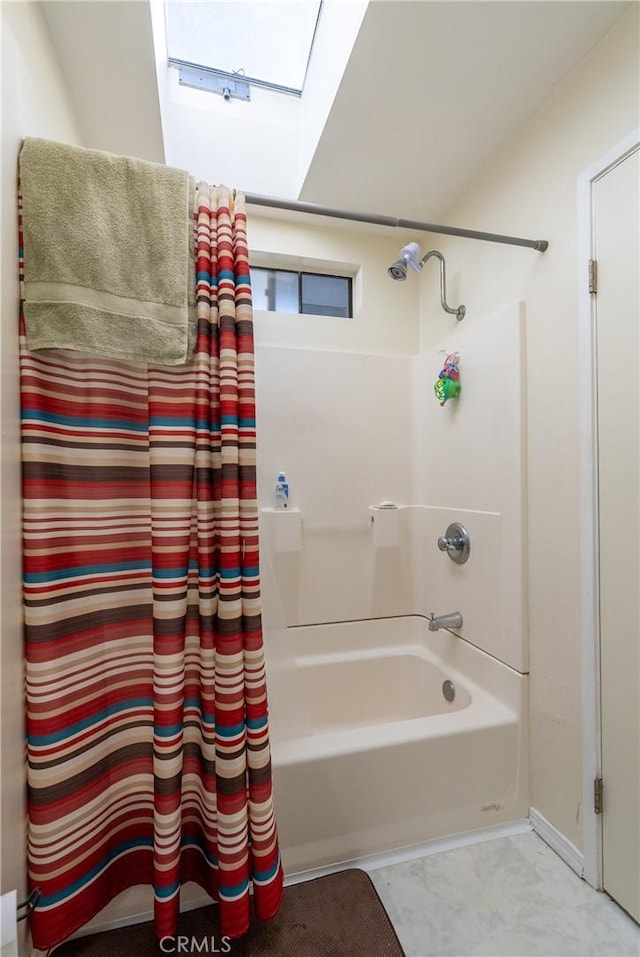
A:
[52,870,404,957]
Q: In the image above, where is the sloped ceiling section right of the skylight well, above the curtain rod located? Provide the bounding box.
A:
[300,0,629,220]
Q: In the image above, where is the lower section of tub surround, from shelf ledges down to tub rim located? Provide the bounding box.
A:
[261,505,528,674]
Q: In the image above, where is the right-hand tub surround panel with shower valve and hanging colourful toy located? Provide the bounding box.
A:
[412,302,529,673]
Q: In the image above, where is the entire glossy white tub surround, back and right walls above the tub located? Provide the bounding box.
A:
[256,303,529,674]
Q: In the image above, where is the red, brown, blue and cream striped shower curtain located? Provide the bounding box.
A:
[21,184,282,949]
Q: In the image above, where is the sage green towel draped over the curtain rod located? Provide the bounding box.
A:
[20,138,195,365]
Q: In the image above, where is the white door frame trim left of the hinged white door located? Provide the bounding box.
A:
[577,129,640,889]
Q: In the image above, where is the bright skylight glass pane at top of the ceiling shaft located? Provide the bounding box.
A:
[166,0,322,94]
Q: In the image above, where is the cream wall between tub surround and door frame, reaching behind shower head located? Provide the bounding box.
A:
[420,5,640,847]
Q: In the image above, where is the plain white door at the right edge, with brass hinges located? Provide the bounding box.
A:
[593,144,640,920]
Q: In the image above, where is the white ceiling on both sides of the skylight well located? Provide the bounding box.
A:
[42,0,632,220]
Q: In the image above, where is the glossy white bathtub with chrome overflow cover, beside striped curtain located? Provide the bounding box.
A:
[265,616,529,874]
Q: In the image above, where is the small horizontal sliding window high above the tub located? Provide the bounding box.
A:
[251,267,353,319]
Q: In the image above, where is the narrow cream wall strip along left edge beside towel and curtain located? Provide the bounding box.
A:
[0,3,80,926]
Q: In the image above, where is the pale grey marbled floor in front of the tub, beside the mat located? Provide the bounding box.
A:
[370,832,640,957]
